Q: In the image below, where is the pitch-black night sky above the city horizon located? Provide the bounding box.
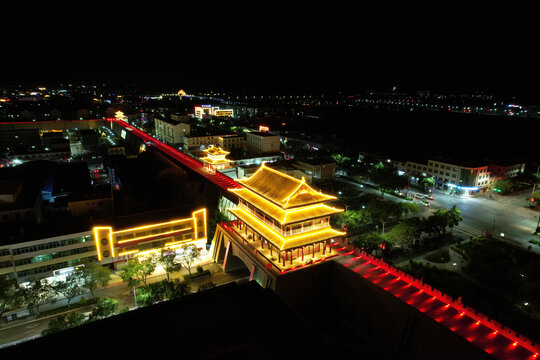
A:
[0,0,540,95]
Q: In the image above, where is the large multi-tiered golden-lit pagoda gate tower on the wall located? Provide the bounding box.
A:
[228,163,345,269]
